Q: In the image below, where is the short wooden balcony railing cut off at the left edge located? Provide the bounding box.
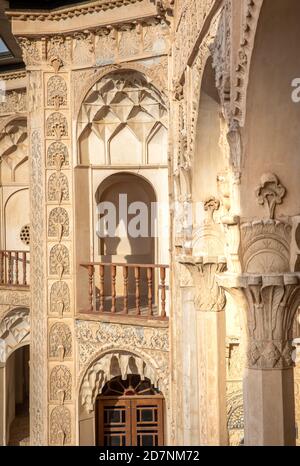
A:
[0,250,30,287]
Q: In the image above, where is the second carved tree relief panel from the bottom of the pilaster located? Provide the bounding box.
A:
[50,365,72,404]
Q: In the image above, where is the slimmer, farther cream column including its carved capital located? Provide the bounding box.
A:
[182,257,228,445]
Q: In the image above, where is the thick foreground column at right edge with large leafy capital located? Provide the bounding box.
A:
[217,273,300,446]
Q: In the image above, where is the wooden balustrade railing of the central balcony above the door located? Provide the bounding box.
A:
[81,262,169,319]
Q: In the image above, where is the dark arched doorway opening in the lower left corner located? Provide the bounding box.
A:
[5,345,29,446]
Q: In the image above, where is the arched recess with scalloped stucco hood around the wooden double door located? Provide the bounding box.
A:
[78,350,170,446]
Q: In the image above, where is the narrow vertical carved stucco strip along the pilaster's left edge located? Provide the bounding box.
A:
[30,126,47,445]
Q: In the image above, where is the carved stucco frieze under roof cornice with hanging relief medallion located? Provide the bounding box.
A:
[17,15,170,68]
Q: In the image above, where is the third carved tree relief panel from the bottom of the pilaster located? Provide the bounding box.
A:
[49,322,72,361]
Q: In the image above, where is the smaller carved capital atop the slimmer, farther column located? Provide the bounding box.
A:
[179,256,226,312]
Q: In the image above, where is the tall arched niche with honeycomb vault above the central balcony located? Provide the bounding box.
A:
[75,70,169,314]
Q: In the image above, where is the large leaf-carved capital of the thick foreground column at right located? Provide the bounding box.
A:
[217,273,300,369]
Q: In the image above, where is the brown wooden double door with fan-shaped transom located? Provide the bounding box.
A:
[96,374,164,447]
